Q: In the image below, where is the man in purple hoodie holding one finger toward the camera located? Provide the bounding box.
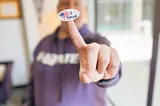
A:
[27,0,122,106]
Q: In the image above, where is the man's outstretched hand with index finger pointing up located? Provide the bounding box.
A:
[66,21,120,83]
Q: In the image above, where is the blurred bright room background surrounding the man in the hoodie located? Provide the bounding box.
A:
[0,0,160,106]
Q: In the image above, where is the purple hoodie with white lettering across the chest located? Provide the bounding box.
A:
[27,25,121,106]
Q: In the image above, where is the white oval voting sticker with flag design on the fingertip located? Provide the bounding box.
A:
[58,9,80,21]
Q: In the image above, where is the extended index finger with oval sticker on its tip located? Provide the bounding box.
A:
[66,21,86,49]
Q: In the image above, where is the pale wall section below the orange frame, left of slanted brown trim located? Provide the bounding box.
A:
[0,19,27,85]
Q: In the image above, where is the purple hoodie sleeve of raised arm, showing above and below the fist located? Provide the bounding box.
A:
[84,34,122,88]
